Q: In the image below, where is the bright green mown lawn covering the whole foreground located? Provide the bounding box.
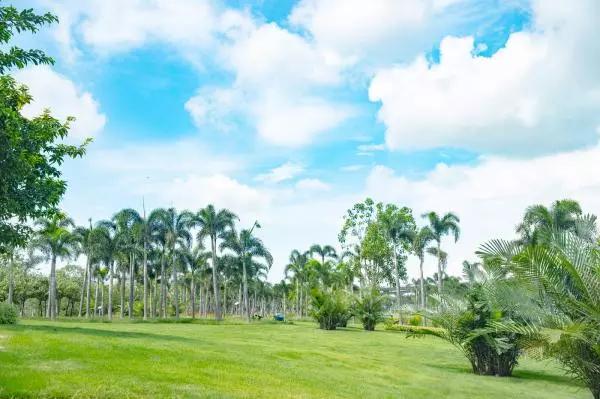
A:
[0,320,591,399]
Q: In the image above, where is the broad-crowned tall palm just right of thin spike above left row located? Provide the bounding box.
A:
[151,208,194,318]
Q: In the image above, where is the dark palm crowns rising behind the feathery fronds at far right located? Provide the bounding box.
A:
[517,199,582,244]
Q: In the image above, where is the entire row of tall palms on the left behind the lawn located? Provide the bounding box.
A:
[31,205,273,320]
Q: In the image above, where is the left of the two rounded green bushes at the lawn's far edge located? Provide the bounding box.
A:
[310,289,352,330]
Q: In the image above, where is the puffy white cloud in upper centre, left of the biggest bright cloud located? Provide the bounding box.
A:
[186,23,354,147]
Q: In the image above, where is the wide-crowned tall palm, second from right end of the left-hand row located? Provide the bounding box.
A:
[195,205,238,320]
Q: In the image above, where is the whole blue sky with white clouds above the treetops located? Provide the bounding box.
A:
[7,0,600,281]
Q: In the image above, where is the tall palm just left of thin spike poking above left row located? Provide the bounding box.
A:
[112,208,142,319]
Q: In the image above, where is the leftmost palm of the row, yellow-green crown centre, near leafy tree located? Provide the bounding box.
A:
[34,213,77,320]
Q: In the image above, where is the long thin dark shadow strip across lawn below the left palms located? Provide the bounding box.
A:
[6,324,196,342]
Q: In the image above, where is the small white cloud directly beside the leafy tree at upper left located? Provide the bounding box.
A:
[14,66,106,140]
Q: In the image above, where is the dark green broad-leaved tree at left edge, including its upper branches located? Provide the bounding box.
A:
[0,6,89,252]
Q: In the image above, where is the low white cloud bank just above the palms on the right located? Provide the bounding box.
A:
[365,146,600,282]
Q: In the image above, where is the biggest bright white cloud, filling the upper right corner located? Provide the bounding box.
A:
[369,0,600,153]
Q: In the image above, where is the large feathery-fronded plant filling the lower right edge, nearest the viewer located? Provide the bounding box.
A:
[481,230,600,399]
